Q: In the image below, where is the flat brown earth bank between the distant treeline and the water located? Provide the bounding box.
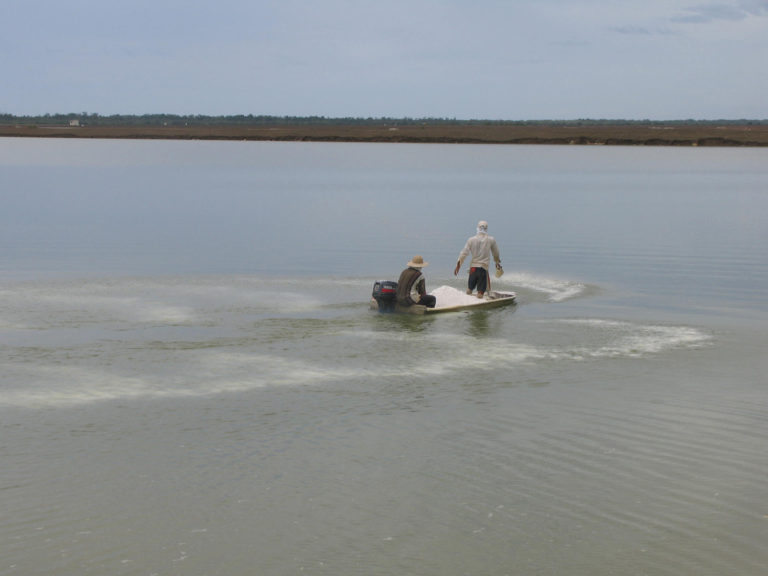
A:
[0,123,768,147]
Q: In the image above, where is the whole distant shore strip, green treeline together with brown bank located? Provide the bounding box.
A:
[0,113,768,147]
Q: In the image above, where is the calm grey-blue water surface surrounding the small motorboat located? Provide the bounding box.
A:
[0,139,768,576]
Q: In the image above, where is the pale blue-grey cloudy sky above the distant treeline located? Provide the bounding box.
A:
[0,0,768,120]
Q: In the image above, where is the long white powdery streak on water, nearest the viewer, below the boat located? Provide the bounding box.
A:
[0,320,710,407]
